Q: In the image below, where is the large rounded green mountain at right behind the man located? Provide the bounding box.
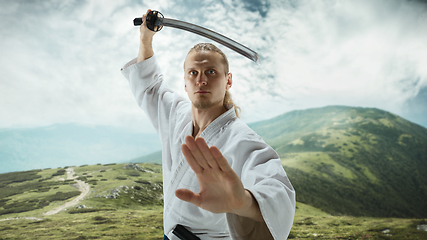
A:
[250,106,427,217]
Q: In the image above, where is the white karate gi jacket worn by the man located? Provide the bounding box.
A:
[122,56,295,240]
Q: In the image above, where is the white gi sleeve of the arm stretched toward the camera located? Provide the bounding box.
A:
[227,139,296,240]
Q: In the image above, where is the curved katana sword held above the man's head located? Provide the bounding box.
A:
[133,11,260,64]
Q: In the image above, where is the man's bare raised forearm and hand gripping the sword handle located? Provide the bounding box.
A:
[137,9,156,62]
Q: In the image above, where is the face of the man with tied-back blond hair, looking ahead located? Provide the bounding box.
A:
[184,51,232,109]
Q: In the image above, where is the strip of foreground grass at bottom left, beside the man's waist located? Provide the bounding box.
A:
[0,206,163,239]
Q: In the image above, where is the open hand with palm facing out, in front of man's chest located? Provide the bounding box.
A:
[175,136,262,221]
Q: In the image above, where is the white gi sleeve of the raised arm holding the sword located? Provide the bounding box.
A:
[122,56,187,140]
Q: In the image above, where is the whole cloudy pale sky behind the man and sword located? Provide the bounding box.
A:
[0,0,427,132]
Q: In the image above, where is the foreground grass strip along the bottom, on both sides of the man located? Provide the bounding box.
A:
[0,203,427,239]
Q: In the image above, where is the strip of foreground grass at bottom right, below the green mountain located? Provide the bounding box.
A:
[289,203,427,240]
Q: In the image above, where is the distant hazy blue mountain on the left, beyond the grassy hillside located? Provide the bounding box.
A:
[0,124,161,173]
